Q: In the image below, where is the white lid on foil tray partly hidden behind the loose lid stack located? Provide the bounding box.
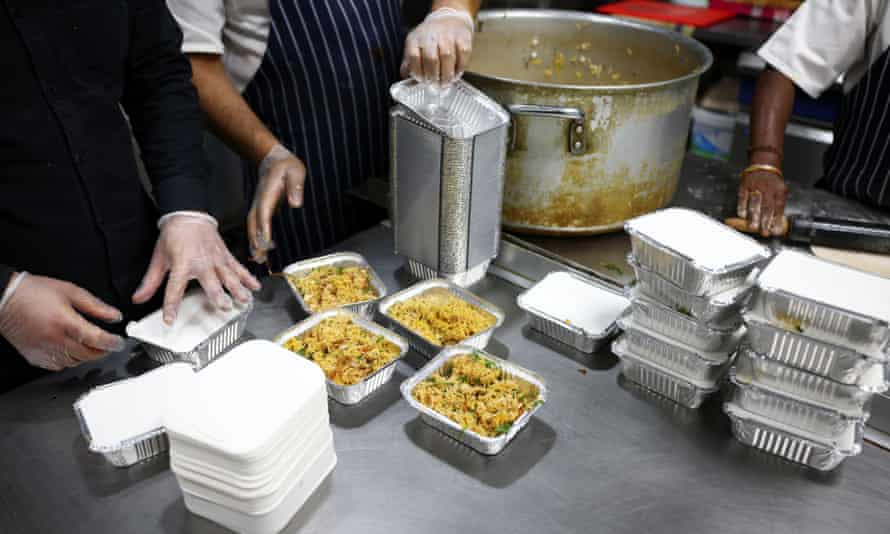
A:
[77,363,195,449]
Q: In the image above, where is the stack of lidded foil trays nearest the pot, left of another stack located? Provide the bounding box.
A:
[612,208,770,408]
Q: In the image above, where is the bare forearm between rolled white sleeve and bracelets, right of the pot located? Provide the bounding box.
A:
[749,69,794,167]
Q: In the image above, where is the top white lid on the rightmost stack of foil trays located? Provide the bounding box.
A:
[757,250,890,322]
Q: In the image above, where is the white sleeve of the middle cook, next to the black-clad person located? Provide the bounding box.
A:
[167,0,226,55]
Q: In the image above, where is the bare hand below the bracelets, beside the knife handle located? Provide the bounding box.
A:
[737,171,788,237]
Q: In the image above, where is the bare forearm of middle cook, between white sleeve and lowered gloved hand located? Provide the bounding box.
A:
[188,54,278,164]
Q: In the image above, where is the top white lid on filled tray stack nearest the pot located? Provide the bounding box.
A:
[627,208,769,270]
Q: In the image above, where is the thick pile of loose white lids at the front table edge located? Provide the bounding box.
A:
[164,341,336,533]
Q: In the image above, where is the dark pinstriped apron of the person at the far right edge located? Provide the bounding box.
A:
[818,49,890,208]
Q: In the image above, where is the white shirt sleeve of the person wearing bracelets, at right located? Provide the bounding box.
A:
[757,0,882,98]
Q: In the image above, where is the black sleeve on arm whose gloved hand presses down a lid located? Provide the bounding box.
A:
[122,0,209,214]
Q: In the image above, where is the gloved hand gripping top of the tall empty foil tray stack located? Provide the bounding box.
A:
[402,7,475,85]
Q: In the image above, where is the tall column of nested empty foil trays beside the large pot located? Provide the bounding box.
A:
[390,80,509,287]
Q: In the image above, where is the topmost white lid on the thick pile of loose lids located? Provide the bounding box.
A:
[164,340,327,456]
